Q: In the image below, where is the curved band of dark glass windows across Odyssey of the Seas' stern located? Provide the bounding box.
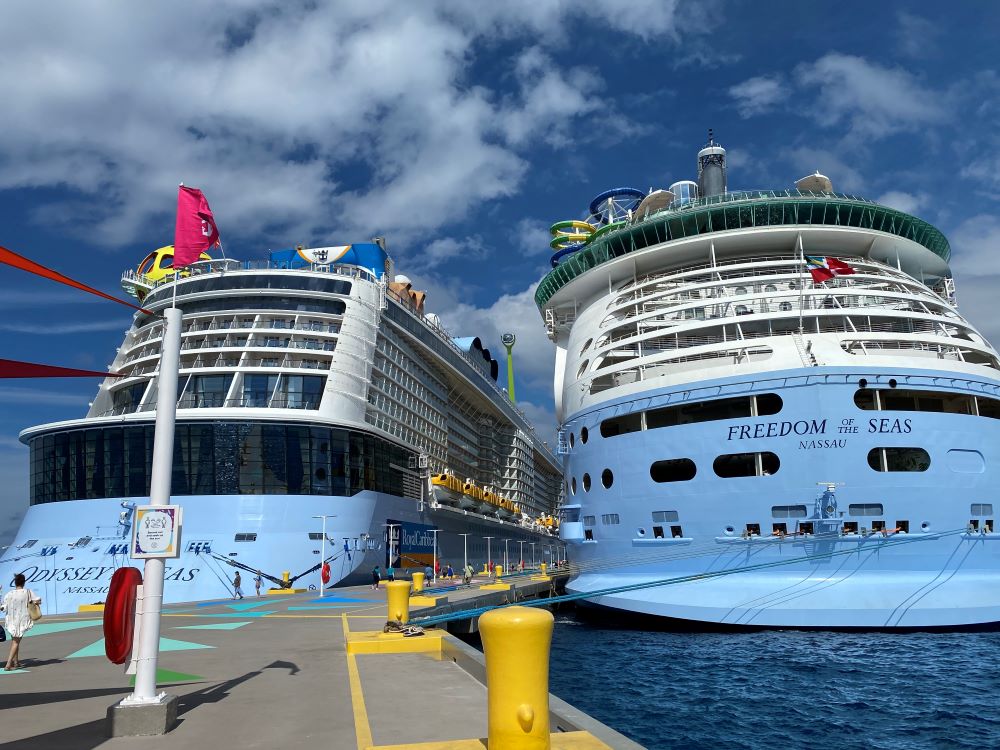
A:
[30,421,416,506]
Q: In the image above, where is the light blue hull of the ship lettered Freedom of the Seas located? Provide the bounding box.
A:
[562,367,1000,628]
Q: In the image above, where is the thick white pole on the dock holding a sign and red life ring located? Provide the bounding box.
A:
[131,306,182,703]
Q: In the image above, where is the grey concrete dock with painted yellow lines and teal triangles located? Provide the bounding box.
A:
[0,578,640,750]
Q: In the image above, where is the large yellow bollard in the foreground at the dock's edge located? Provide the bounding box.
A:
[479,607,554,750]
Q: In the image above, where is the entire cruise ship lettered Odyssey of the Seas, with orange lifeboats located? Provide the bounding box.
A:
[0,240,562,613]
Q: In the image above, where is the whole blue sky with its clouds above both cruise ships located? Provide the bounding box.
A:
[0,0,1000,545]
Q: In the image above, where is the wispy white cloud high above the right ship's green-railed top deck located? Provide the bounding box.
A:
[795,53,947,139]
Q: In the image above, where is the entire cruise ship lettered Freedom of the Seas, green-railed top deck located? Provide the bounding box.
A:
[535,134,1000,630]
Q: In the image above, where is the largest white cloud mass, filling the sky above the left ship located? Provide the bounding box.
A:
[0,0,715,250]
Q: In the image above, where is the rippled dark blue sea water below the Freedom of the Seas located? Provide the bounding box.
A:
[550,613,1000,750]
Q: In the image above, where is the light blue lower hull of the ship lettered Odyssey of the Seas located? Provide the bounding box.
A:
[0,492,557,614]
